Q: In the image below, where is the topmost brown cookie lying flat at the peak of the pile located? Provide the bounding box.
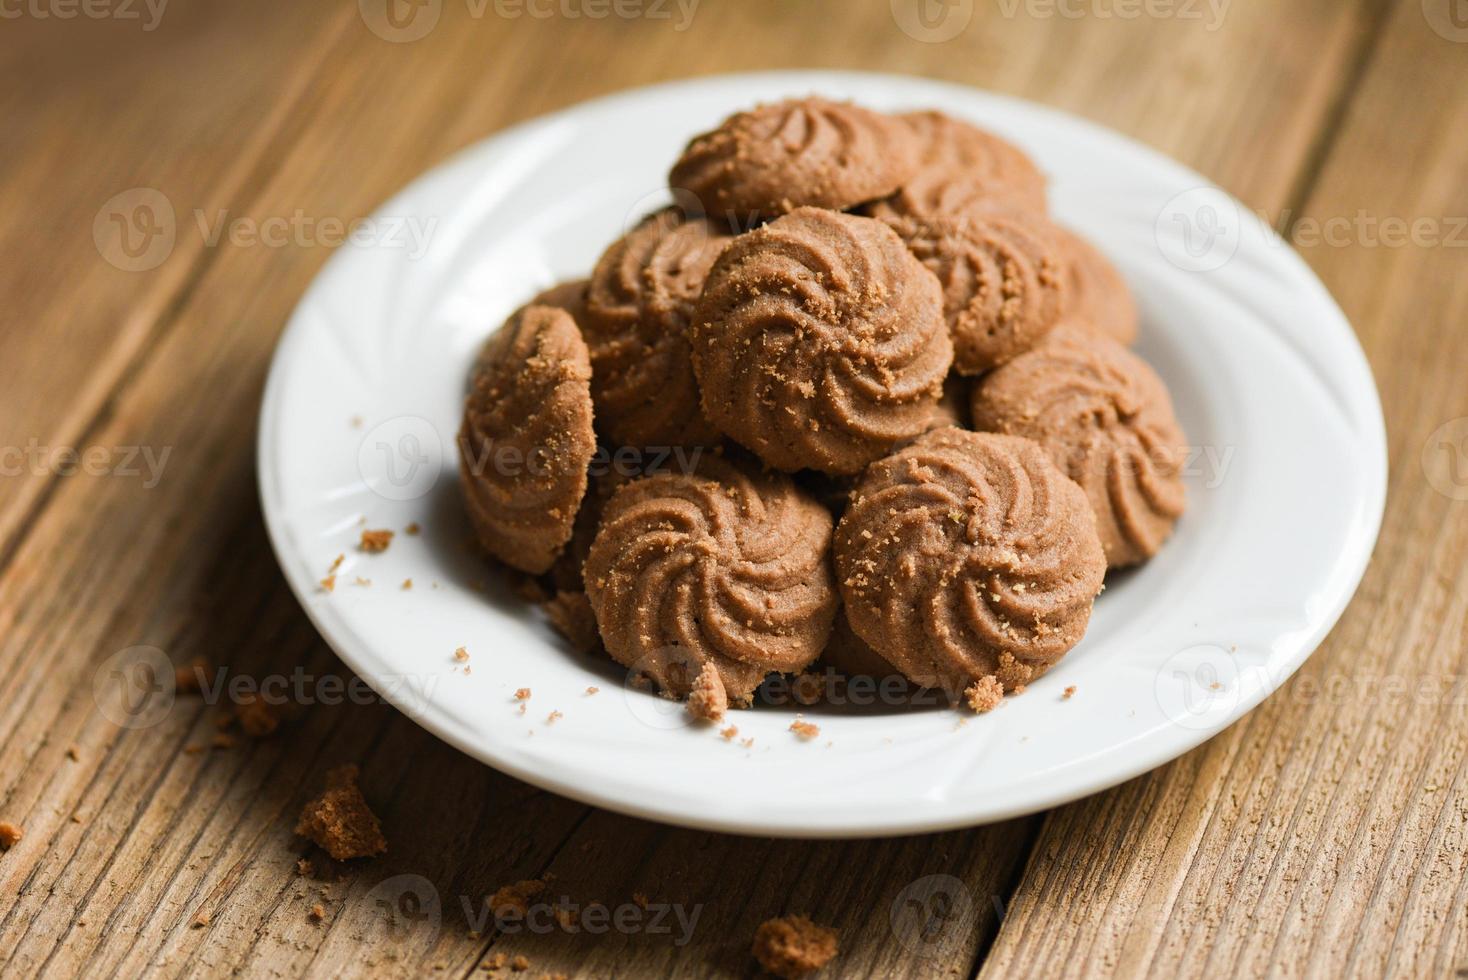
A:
[668,98,918,220]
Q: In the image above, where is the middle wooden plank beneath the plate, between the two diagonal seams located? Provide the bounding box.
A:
[0,0,1379,976]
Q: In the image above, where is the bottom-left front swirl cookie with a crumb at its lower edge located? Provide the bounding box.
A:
[586,453,838,704]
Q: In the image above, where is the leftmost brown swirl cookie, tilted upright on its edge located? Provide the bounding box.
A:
[458,307,596,575]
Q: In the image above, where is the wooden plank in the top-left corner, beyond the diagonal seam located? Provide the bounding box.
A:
[0,0,352,557]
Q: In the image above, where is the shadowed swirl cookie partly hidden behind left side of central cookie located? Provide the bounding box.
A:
[580,208,731,447]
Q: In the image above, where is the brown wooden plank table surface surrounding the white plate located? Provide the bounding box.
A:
[0,0,1468,977]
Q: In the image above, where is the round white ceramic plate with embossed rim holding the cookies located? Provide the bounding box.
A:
[260,72,1386,836]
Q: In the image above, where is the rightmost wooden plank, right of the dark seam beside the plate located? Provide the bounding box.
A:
[984,3,1468,976]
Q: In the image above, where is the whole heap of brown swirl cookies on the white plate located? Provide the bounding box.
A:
[458,98,1185,717]
